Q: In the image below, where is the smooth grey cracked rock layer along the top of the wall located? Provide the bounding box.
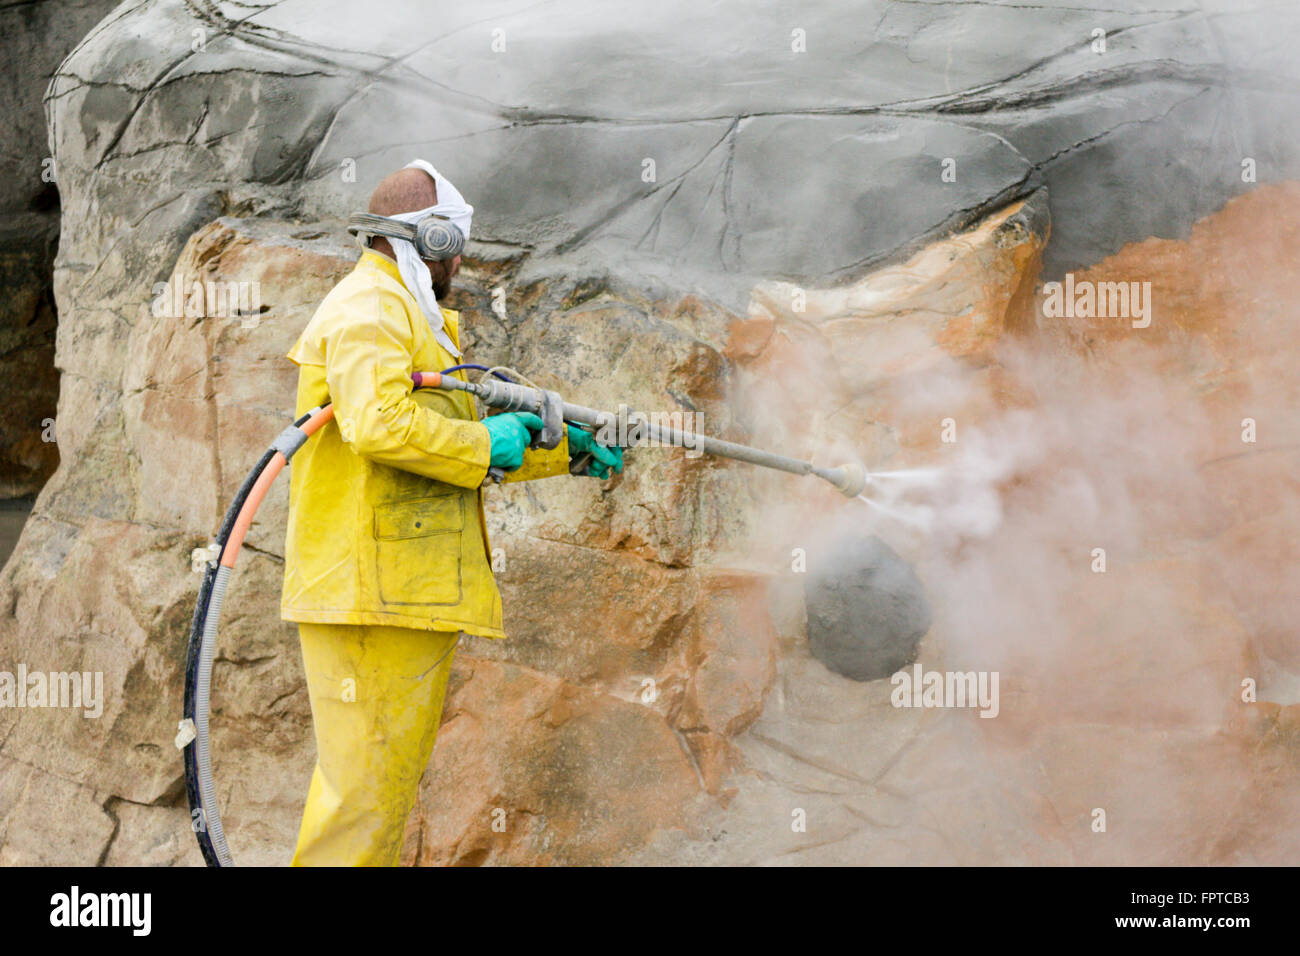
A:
[40,0,1300,304]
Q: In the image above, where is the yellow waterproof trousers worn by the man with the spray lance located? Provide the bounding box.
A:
[293,624,460,866]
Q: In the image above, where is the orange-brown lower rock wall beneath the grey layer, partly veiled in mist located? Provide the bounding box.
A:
[10,185,1300,864]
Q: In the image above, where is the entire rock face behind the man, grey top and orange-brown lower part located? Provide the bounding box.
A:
[0,0,1300,864]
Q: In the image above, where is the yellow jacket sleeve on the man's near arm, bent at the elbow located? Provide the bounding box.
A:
[325,280,491,488]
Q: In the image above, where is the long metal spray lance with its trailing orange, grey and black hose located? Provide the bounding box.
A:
[176,365,867,866]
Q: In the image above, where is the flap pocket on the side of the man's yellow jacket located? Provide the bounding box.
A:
[374,490,465,605]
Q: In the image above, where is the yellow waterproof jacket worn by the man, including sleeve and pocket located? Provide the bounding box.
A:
[281,251,506,637]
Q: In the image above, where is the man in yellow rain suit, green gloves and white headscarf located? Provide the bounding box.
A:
[281,160,623,866]
